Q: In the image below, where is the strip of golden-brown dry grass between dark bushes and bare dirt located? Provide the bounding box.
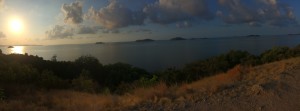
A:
[0,58,300,111]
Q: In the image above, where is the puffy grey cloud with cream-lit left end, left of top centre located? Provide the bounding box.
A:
[86,0,145,29]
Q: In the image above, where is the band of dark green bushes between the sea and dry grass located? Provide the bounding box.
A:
[0,45,300,95]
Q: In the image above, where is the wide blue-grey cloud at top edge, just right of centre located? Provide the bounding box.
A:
[144,0,213,24]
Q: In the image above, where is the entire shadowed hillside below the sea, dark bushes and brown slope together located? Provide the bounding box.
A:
[0,46,300,111]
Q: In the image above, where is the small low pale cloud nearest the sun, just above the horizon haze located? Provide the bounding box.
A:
[45,25,74,39]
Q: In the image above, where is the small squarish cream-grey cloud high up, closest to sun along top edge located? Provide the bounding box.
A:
[61,1,83,24]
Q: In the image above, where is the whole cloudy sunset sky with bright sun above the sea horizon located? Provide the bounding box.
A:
[0,0,300,45]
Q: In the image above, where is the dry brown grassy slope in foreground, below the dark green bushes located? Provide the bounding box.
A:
[0,58,300,111]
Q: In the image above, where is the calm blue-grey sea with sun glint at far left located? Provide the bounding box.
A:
[0,36,300,71]
